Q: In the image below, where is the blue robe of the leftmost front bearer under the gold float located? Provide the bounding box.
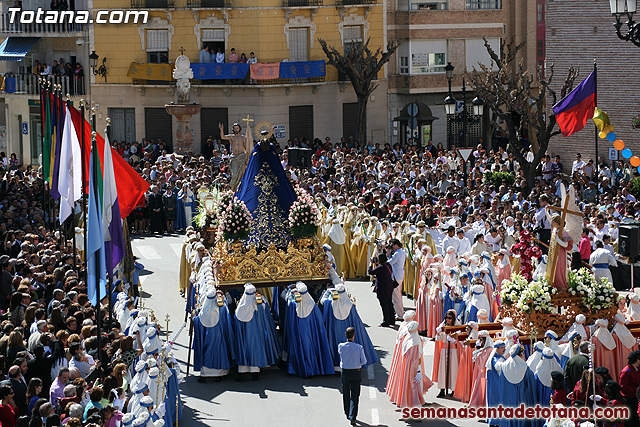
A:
[193,304,236,371]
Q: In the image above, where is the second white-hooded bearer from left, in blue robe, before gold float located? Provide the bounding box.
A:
[234,283,279,381]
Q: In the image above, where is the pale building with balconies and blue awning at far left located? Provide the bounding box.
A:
[0,0,91,164]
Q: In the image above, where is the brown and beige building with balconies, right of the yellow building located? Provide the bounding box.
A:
[387,0,544,147]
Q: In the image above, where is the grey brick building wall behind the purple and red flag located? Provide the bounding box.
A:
[546,0,640,164]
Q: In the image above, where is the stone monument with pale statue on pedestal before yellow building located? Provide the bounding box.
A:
[164,48,200,154]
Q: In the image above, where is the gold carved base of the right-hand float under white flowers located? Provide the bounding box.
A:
[500,293,618,336]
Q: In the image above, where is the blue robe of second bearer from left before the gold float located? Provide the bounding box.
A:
[233,301,280,368]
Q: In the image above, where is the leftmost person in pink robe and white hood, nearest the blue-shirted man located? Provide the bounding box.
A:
[386,321,433,408]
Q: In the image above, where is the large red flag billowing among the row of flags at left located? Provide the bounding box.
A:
[69,106,149,219]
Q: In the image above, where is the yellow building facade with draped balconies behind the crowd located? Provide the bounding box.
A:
[91,0,388,151]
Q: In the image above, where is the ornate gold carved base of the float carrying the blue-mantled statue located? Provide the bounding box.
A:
[214,238,329,287]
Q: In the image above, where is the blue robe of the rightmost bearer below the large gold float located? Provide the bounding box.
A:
[321,292,380,368]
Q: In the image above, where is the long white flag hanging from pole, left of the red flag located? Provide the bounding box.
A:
[58,107,82,223]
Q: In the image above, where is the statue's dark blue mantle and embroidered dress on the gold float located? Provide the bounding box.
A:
[236,142,297,250]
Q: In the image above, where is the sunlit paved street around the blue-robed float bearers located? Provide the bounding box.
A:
[133,236,486,427]
